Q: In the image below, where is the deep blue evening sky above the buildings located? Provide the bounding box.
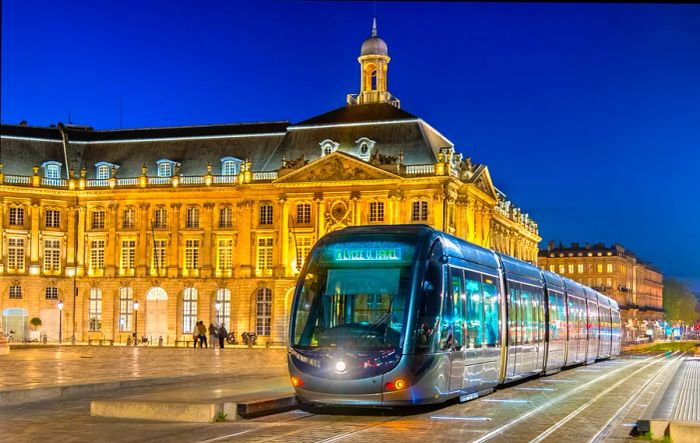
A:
[2,0,700,289]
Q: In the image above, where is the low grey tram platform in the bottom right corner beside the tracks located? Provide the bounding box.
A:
[637,357,700,442]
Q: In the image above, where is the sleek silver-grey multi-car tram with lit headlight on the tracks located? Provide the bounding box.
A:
[288,225,620,406]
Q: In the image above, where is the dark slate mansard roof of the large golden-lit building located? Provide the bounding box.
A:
[0,103,452,177]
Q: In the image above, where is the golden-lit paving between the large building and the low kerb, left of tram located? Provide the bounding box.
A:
[0,346,287,390]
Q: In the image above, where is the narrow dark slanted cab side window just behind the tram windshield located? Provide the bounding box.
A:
[415,261,442,352]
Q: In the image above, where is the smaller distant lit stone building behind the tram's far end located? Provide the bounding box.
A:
[538,242,664,340]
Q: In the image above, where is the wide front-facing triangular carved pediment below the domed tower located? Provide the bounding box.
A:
[275,151,400,183]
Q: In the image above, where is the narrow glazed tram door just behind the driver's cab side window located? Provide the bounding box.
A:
[443,268,466,392]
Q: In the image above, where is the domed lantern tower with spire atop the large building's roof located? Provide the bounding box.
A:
[348,18,399,108]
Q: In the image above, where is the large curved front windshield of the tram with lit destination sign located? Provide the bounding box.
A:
[293,235,417,350]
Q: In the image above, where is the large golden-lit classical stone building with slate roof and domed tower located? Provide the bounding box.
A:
[0,22,540,345]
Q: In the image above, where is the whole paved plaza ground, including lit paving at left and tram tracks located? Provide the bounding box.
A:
[0,346,696,443]
